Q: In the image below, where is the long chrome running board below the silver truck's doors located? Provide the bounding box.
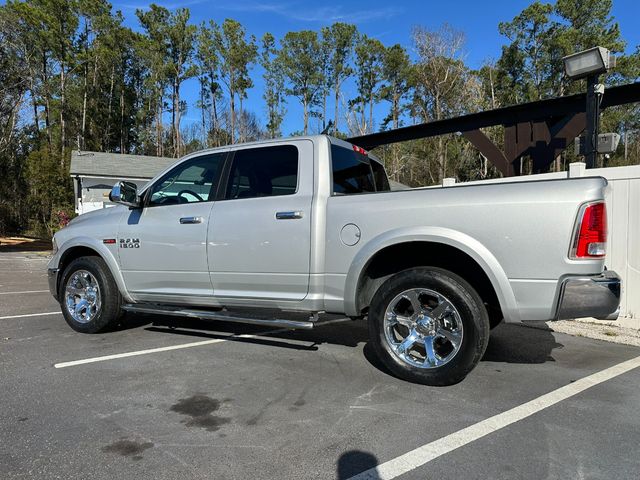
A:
[122,304,317,330]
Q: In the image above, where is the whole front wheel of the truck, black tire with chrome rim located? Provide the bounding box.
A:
[58,256,123,333]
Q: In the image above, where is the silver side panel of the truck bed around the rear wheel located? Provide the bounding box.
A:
[325,177,607,322]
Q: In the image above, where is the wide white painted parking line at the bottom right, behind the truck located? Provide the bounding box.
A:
[349,357,640,480]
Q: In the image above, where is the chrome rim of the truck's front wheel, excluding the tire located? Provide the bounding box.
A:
[64,270,101,323]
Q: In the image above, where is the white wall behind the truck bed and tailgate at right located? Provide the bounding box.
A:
[443,162,640,329]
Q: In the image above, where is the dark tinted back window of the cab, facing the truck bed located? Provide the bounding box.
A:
[331,144,390,195]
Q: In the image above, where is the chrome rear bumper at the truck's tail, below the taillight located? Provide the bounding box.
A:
[556,270,622,320]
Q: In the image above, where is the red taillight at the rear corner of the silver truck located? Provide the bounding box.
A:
[571,202,607,259]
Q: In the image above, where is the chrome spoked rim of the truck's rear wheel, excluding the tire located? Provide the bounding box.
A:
[384,288,464,368]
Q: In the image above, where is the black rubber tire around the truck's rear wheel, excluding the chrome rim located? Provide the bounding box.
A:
[369,267,489,386]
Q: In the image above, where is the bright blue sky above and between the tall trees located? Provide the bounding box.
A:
[113,0,640,134]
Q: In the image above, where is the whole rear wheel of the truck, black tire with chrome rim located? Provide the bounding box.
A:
[369,267,489,386]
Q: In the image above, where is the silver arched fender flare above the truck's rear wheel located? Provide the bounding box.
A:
[344,227,520,322]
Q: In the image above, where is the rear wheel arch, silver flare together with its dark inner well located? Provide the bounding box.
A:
[345,227,520,322]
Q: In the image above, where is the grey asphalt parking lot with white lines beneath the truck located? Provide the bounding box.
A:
[0,252,640,479]
